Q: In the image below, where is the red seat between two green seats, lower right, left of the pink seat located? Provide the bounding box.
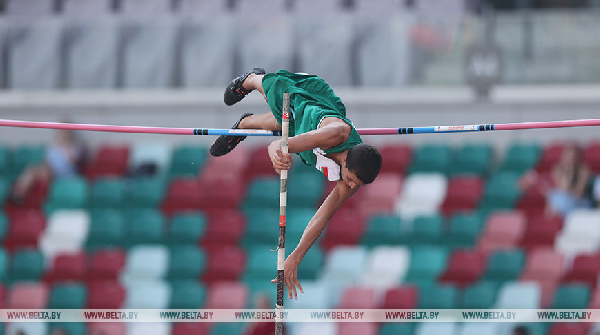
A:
[440,250,486,287]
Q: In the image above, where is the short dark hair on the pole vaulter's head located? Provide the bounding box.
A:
[346,143,381,184]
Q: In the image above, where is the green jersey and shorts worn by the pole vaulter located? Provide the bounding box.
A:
[262,70,362,166]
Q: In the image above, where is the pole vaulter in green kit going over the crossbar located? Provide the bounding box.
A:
[210,68,381,299]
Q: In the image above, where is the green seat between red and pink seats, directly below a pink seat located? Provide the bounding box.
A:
[482,249,525,284]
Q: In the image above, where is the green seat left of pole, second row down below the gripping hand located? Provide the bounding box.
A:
[242,209,280,247]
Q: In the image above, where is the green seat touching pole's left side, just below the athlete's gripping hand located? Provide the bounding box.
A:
[242,177,280,209]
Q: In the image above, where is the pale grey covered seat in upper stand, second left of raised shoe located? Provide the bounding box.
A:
[121,21,178,89]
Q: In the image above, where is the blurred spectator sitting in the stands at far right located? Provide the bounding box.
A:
[522,144,591,216]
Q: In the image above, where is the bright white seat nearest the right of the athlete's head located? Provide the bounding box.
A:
[394,173,448,219]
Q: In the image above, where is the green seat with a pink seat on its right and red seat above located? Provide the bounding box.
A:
[443,213,485,249]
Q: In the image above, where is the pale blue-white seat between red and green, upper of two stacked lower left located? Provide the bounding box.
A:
[121,245,169,282]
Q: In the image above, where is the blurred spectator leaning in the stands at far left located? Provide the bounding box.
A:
[11,121,85,203]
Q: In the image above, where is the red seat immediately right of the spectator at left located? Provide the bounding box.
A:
[85,145,129,179]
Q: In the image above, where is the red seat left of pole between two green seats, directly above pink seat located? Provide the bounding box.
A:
[202,245,246,284]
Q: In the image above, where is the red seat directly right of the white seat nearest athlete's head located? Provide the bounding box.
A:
[441,175,484,216]
